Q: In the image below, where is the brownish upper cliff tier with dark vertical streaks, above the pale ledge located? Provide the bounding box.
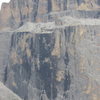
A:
[0,0,100,30]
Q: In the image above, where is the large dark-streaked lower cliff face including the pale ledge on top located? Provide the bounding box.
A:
[2,17,100,100]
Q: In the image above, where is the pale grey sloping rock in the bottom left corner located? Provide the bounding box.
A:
[0,82,21,100]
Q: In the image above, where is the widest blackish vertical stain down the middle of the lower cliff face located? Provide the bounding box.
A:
[38,34,57,100]
